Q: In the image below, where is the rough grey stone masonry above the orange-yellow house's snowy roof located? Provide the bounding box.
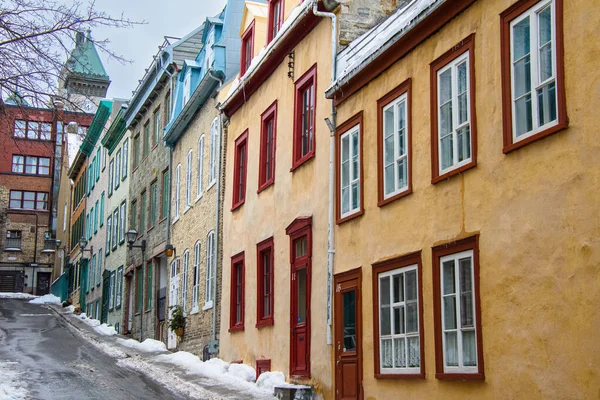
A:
[338,0,409,48]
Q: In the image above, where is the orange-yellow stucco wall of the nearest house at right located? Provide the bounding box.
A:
[335,0,600,399]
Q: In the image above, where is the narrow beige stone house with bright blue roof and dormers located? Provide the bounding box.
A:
[165,0,244,358]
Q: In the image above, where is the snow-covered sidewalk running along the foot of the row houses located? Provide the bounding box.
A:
[46,304,274,400]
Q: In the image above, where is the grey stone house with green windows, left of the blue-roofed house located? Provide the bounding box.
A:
[123,28,202,340]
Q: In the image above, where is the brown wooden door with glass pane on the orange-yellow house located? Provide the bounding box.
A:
[334,269,362,400]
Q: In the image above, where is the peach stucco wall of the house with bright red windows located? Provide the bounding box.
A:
[220,21,332,398]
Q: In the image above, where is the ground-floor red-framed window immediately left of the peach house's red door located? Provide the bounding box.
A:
[256,237,275,328]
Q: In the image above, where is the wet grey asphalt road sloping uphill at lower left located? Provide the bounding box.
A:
[0,299,184,400]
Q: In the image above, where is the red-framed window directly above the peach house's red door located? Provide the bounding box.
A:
[292,64,317,170]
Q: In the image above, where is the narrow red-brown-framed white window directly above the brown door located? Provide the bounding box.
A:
[336,111,364,224]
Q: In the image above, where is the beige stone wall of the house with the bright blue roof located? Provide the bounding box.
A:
[171,98,223,356]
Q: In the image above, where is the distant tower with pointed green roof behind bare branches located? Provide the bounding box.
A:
[58,30,110,113]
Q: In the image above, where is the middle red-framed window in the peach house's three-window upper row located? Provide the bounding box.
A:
[258,101,277,192]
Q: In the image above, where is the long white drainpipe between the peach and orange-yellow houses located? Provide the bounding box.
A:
[313,0,337,345]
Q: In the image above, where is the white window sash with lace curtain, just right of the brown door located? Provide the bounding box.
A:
[379,265,421,374]
